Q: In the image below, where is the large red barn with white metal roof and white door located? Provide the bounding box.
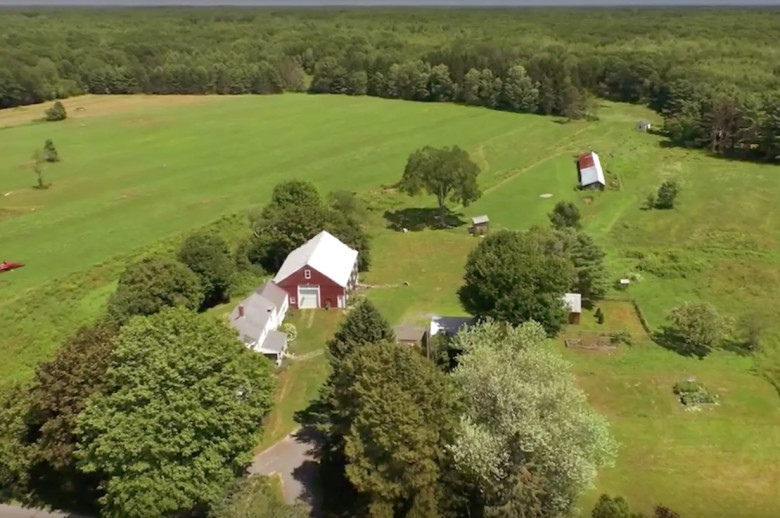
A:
[274,230,358,309]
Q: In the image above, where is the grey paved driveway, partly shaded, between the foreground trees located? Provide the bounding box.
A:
[249,430,320,516]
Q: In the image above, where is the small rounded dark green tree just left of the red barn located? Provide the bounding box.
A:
[178,233,236,307]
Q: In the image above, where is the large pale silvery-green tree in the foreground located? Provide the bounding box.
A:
[451,322,616,518]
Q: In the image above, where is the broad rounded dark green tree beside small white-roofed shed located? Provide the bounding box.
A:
[460,230,575,335]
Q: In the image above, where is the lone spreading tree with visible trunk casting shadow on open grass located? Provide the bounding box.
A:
[400,146,482,227]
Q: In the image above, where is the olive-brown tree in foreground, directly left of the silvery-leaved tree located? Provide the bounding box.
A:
[333,343,456,518]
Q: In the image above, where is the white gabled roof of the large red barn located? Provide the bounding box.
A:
[274,230,358,287]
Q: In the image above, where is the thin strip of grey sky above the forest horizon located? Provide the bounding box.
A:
[0,0,780,7]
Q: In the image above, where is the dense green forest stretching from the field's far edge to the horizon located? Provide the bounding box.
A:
[0,9,780,161]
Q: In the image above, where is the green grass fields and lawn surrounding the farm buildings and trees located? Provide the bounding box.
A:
[0,95,780,518]
